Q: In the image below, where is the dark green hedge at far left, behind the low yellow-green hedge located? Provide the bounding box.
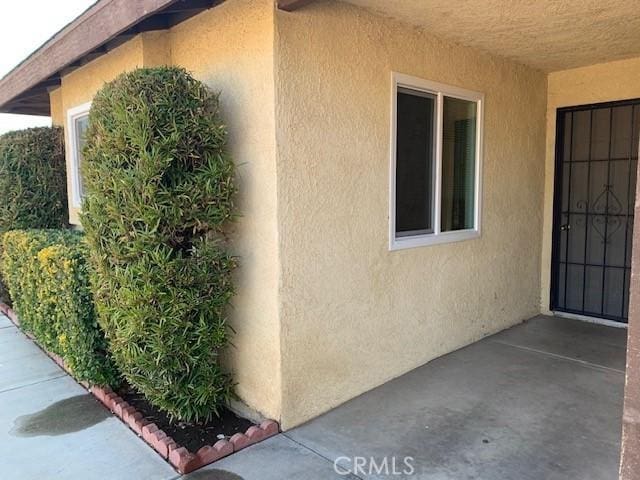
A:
[0,127,68,232]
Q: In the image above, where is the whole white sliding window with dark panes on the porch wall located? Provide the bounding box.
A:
[389,73,484,250]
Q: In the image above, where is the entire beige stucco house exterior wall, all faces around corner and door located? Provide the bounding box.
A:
[50,0,640,429]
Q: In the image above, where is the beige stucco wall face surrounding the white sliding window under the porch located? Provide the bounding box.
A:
[276,1,546,428]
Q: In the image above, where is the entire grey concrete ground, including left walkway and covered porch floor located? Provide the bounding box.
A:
[0,316,626,480]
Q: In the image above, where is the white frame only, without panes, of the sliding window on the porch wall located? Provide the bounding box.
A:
[389,72,484,251]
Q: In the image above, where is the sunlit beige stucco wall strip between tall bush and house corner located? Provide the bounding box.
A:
[170,0,281,419]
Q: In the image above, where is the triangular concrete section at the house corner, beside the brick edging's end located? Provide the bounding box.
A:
[183,435,357,480]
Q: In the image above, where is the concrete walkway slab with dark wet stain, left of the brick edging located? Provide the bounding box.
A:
[0,376,177,480]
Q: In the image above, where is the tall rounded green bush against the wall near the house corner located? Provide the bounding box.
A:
[81,67,236,421]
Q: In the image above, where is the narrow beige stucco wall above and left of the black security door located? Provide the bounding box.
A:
[541,57,640,313]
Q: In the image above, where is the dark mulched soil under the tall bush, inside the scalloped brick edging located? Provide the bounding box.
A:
[117,387,254,453]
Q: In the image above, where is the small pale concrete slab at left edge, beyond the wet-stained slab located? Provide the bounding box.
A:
[0,327,65,392]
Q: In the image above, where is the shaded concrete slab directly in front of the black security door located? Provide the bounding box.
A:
[491,315,627,372]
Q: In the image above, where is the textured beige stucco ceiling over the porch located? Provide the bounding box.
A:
[344,0,640,72]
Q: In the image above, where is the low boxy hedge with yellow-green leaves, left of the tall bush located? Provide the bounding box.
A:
[0,230,119,385]
